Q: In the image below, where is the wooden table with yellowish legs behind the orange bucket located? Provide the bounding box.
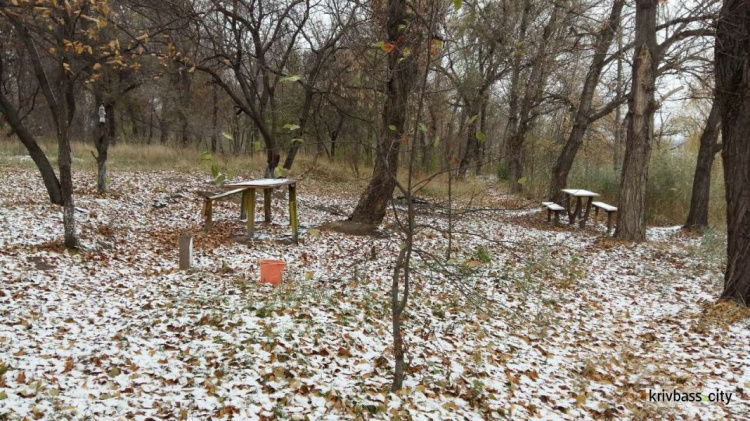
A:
[224,178,299,243]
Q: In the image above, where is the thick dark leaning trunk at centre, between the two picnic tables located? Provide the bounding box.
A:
[350,0,421,226]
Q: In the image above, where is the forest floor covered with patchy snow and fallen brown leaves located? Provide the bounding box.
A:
[0,167,750,420]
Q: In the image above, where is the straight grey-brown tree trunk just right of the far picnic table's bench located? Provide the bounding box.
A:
[615,0,658,241]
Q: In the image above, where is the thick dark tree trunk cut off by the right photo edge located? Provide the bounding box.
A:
[715,0,750,305]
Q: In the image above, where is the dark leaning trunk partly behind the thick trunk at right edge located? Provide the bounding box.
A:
[685,101,721,230]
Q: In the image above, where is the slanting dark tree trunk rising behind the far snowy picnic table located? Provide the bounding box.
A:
[549,0,625,203]
